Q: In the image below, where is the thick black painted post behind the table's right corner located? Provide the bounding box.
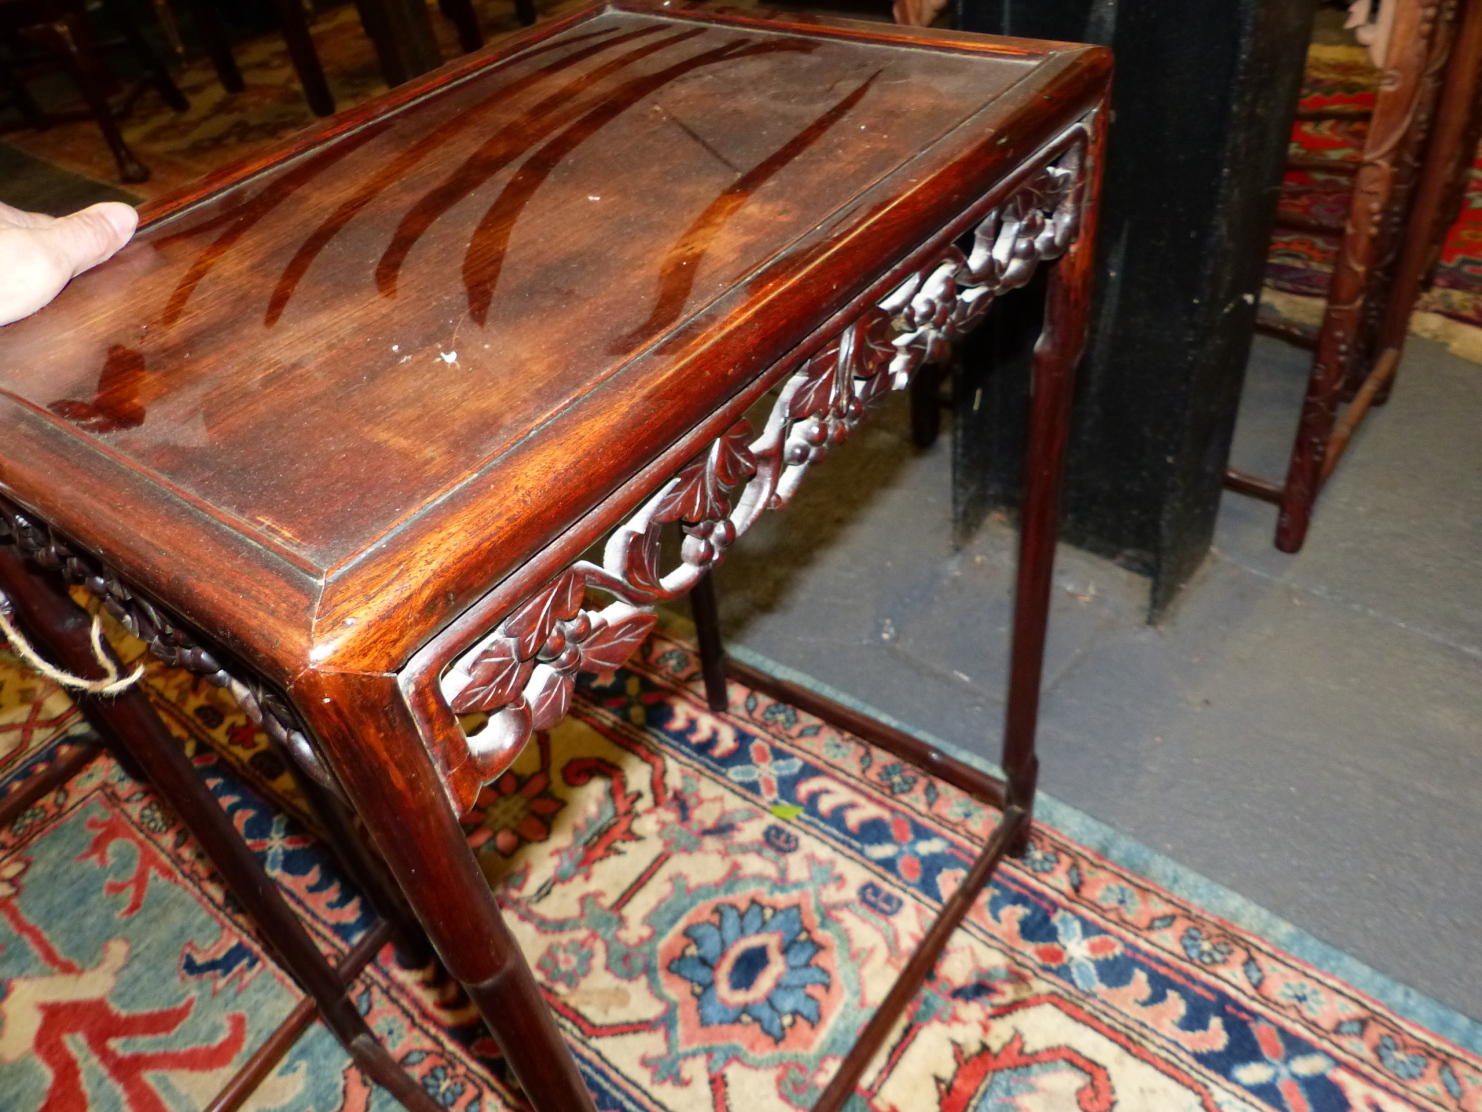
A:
[954,0,1315,618]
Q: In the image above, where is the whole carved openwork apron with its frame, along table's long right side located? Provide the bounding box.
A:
[411,117,1095,814]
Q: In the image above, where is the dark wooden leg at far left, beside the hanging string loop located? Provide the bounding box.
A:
[0,546,439,1112]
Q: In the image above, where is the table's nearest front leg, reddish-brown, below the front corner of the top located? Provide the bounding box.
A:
[293,672,596,1112]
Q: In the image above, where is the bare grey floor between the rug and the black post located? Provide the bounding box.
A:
[699,338,1482,1017]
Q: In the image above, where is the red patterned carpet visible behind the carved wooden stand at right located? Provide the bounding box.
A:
[1266,44,1482,335]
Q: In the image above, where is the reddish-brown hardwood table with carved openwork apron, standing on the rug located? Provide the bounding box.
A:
[0,3,1110,1112]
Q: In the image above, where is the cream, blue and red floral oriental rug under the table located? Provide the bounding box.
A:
[0,633,1482,1112]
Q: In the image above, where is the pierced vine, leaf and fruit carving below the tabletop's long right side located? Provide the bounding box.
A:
[442,134,1082,768]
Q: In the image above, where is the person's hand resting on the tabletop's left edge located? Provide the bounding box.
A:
[0,200,139,325]
